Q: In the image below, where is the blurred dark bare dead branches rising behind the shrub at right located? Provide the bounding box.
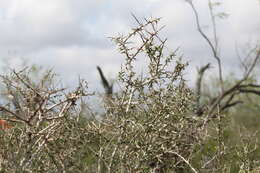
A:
[186,0,260,121]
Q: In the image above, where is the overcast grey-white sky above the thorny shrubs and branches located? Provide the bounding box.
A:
[0,0,260,92]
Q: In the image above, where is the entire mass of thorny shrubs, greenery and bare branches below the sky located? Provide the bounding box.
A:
[0,0,260,173]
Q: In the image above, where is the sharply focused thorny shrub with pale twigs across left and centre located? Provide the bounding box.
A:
[0,16,258,173]
